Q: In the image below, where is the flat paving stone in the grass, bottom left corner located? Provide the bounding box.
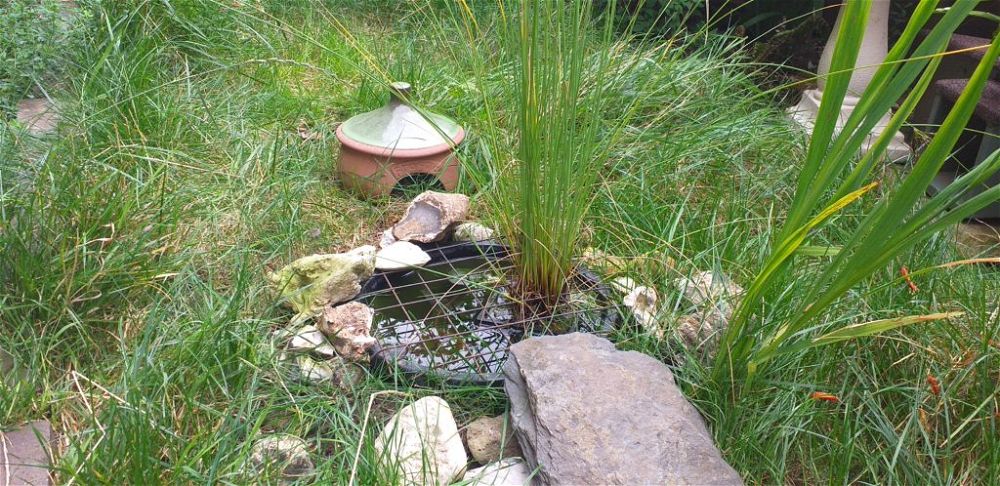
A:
[0,420,52,486]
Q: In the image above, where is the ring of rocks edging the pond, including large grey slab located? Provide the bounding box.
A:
[248,191,742,485]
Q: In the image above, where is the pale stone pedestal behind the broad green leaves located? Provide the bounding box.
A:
[788,0,912,161]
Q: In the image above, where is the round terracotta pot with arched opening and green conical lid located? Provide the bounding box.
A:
[337,83,465,196]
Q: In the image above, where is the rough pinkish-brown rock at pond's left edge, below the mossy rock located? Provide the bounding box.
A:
[316,302,375,361]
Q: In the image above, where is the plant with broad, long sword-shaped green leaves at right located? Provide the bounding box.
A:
[713,0,1000,394]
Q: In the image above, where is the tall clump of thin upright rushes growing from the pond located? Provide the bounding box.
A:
[452,0,680,305]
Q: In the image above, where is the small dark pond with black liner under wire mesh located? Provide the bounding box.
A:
[355,241,621,386]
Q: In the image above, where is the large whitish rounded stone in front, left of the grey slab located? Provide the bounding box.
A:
[375,397,468,485]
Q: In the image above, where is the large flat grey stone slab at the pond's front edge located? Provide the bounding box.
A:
[504,333,742,485]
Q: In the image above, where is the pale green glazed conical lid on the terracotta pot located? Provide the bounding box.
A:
[341,82,462,150]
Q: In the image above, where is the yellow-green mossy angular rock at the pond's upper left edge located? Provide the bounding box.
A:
[270,246,375,316]
